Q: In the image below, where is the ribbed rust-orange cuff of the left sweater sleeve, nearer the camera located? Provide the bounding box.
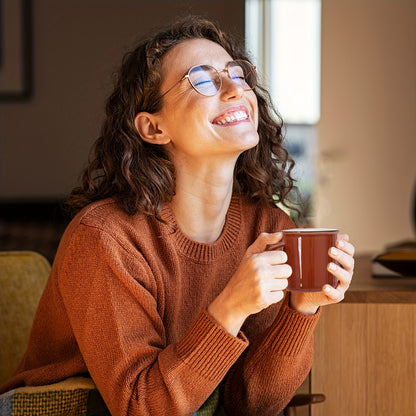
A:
[176,311,249,380]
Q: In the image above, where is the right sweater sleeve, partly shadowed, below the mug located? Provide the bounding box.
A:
[224,293,320,416]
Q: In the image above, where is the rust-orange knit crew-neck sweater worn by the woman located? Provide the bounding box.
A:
[1,196,319,416]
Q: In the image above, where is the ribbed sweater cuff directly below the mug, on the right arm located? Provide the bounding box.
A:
[266,294,321,356]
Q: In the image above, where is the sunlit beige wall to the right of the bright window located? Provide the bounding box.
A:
[315,0,416,252]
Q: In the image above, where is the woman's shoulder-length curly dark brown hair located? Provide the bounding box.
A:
[67,16,296,217]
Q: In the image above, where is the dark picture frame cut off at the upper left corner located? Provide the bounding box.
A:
[0,0,33,101]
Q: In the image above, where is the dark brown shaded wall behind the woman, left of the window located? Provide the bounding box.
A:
[0,0,244,200]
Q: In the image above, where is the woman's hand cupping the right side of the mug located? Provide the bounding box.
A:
[290,234,355,315]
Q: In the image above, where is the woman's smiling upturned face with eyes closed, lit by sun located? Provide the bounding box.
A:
[156,39,259,165]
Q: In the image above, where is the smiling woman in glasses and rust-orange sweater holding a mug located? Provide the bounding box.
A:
[3,18,354,416]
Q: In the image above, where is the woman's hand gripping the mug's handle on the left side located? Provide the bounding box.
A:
[208,232,292,336]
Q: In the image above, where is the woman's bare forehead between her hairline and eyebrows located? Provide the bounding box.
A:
[162,39,232,80]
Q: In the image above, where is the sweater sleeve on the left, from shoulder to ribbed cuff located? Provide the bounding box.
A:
[58,225,248,416]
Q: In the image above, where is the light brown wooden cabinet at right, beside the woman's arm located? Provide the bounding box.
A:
[311,256,416,416]
